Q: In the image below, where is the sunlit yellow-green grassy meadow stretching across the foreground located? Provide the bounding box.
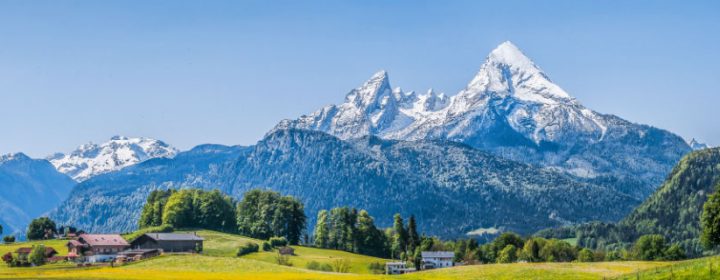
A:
[0,230,720,280]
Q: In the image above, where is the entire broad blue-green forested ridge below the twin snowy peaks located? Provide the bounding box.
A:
[53,130,637,237]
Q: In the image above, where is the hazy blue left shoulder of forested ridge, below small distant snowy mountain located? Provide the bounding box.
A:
[51,145,245,232]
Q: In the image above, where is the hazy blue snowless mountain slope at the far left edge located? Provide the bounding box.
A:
[0,153,75,234]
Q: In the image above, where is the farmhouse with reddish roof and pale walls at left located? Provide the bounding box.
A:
[67,234,130,262]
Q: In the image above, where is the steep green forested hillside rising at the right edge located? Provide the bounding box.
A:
[620,148,720,253]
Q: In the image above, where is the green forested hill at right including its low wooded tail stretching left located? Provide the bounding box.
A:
[537,148,720,256]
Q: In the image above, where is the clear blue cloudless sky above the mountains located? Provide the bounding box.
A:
[0,1,720,157]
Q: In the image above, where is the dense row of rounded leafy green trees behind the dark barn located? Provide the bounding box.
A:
[138,189,307,244]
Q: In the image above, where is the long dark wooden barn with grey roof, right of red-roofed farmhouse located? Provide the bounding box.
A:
[131,233,203,252]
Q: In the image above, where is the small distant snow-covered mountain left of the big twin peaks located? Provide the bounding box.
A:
[48,136,178,182]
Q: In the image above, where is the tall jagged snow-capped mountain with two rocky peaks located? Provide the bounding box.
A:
[271,42,690,198]
